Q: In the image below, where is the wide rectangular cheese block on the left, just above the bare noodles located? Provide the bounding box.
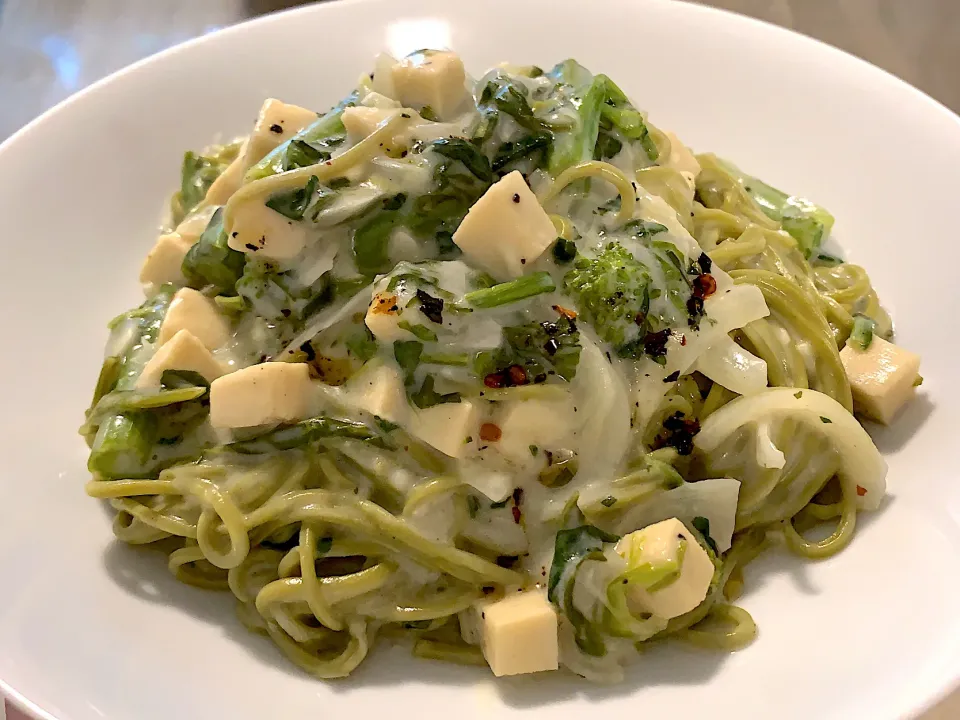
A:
[210,362,313,428]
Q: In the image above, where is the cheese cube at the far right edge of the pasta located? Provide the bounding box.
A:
[840,335,920,425]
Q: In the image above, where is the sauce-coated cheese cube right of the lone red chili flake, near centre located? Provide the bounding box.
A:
[497,398,576,464]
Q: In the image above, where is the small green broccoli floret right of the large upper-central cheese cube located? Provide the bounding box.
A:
[563,242,651,349]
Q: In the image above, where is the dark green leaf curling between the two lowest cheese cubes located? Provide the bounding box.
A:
[547,525,618,657]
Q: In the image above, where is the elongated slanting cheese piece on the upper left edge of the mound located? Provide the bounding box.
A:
[205,98,318,205]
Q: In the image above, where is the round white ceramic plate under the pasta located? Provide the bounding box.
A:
[0,0,960,720]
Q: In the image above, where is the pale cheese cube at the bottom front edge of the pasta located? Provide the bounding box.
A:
[482,590,560,677]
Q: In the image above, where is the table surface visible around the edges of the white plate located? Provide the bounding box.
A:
[0,0,960,720]
